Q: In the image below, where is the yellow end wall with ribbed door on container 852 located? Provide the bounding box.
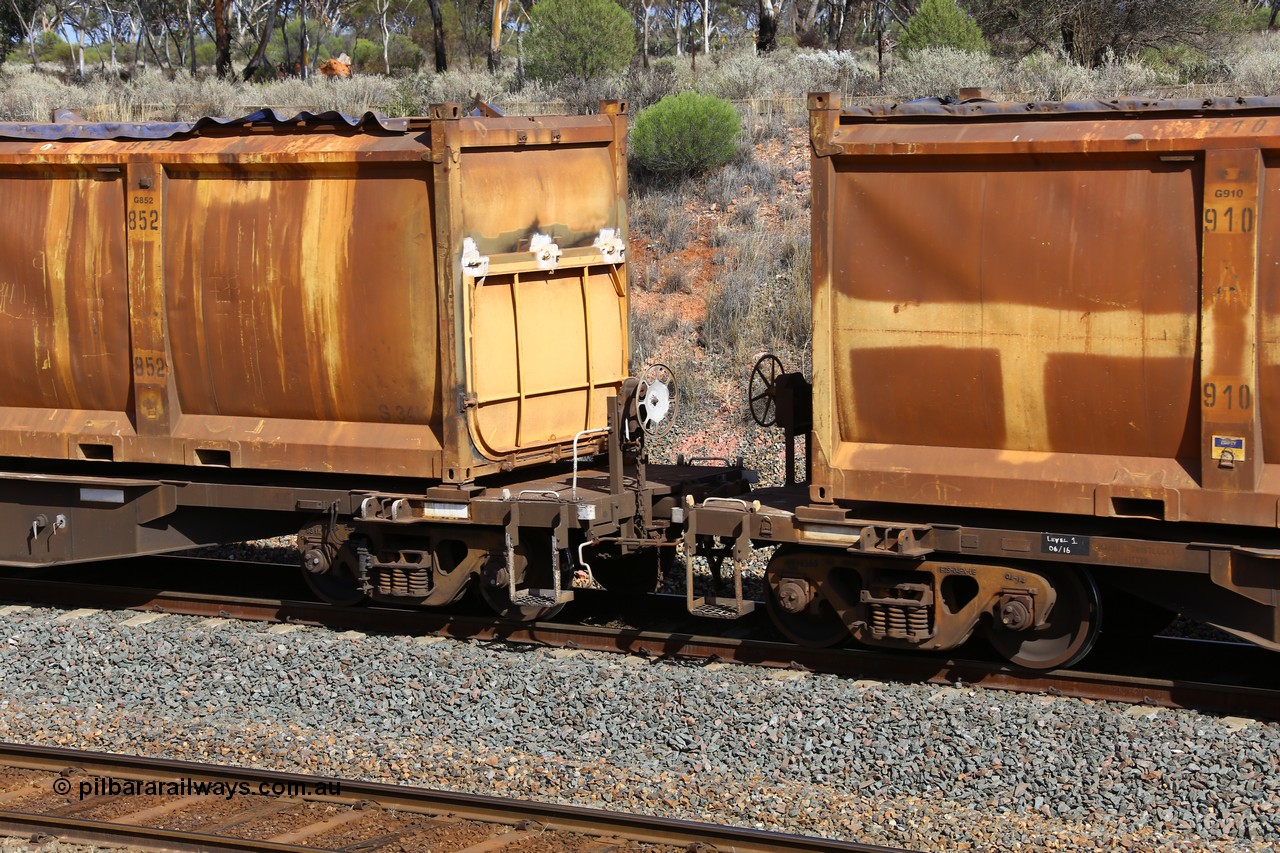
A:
[461,133,627,459]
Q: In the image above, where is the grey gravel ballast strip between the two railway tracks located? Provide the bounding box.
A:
[0,608,1280,850]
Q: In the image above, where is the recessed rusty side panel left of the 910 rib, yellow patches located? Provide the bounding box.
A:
[832,159,1199,459]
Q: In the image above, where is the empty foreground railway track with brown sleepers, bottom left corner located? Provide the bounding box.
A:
[0,743,893,853]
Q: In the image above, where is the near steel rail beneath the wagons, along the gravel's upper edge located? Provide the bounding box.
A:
[0,578,1280,720]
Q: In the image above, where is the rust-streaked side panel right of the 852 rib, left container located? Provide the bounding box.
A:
[165,167,440,424]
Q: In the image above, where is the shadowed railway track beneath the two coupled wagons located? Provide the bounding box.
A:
[0,550,1280,720]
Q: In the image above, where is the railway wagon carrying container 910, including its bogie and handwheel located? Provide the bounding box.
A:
[695,95,1280,667]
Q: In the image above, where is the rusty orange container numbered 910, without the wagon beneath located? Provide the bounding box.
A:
[810,95,1280,528]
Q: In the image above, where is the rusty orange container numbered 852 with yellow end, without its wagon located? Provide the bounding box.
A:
[0,102,627,483]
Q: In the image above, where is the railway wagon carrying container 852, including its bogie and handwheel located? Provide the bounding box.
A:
[0,101,742,615]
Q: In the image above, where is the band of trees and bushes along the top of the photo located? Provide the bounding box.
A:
[0,0,1259,86]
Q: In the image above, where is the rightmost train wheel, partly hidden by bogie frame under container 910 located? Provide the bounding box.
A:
[987,569,1102,670]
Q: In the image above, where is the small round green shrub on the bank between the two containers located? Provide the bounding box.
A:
[631,92,742,175]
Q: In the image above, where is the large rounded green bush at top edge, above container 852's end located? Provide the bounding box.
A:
[526,0,636,83]
